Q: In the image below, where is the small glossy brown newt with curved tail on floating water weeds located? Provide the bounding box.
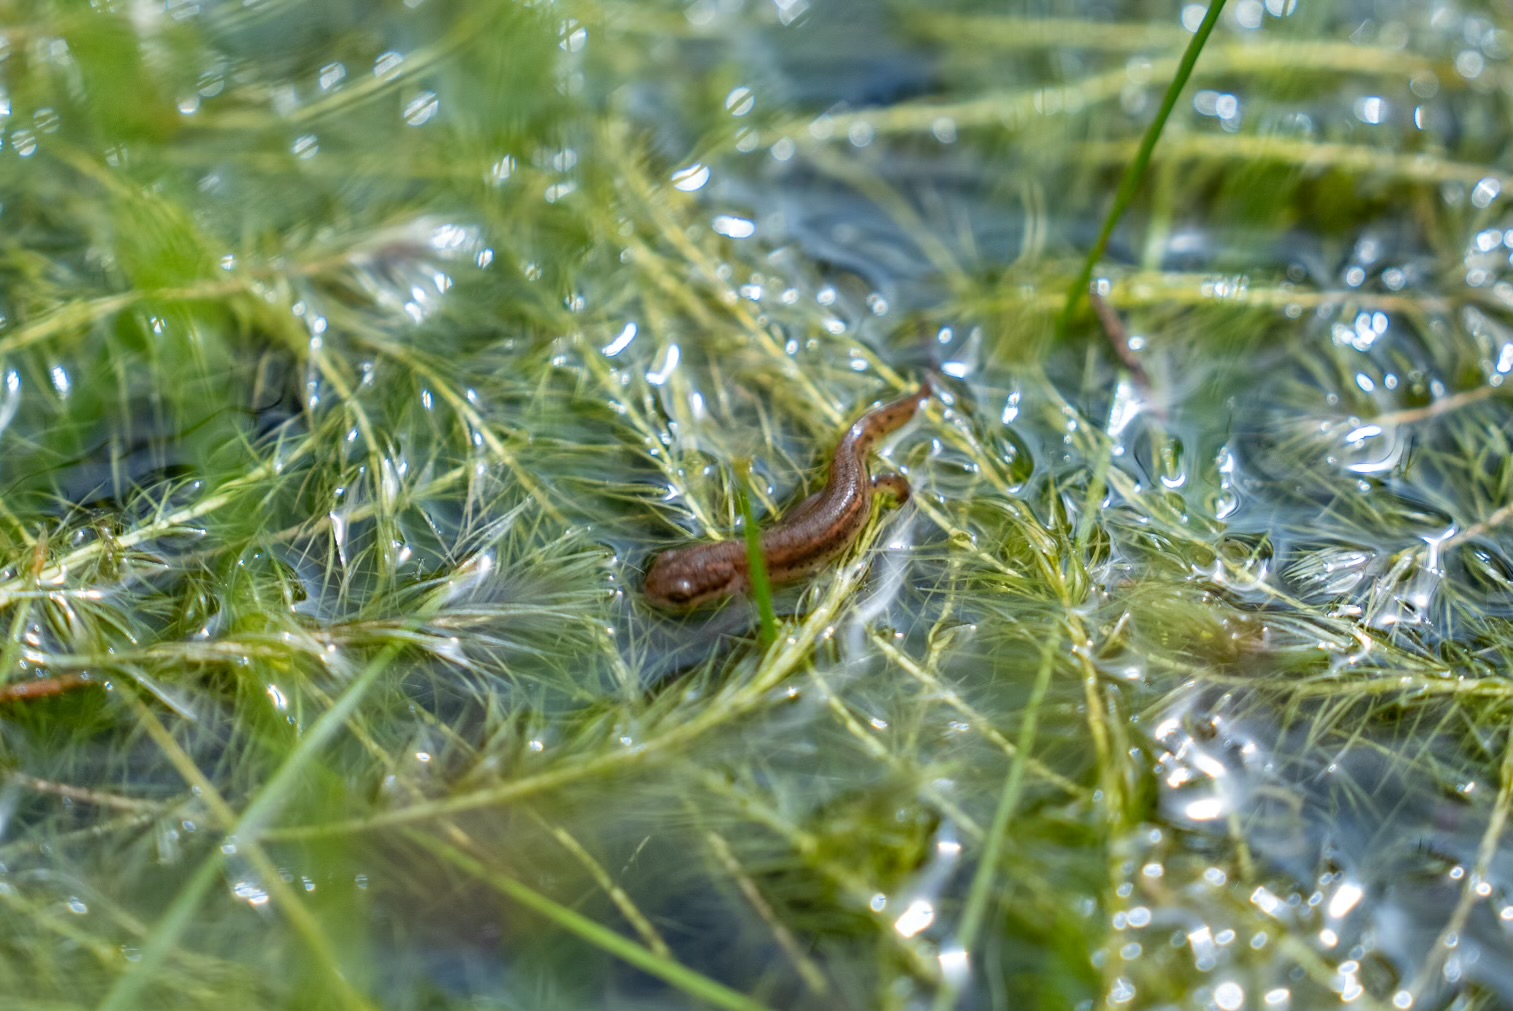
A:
[645,383,930,610]
